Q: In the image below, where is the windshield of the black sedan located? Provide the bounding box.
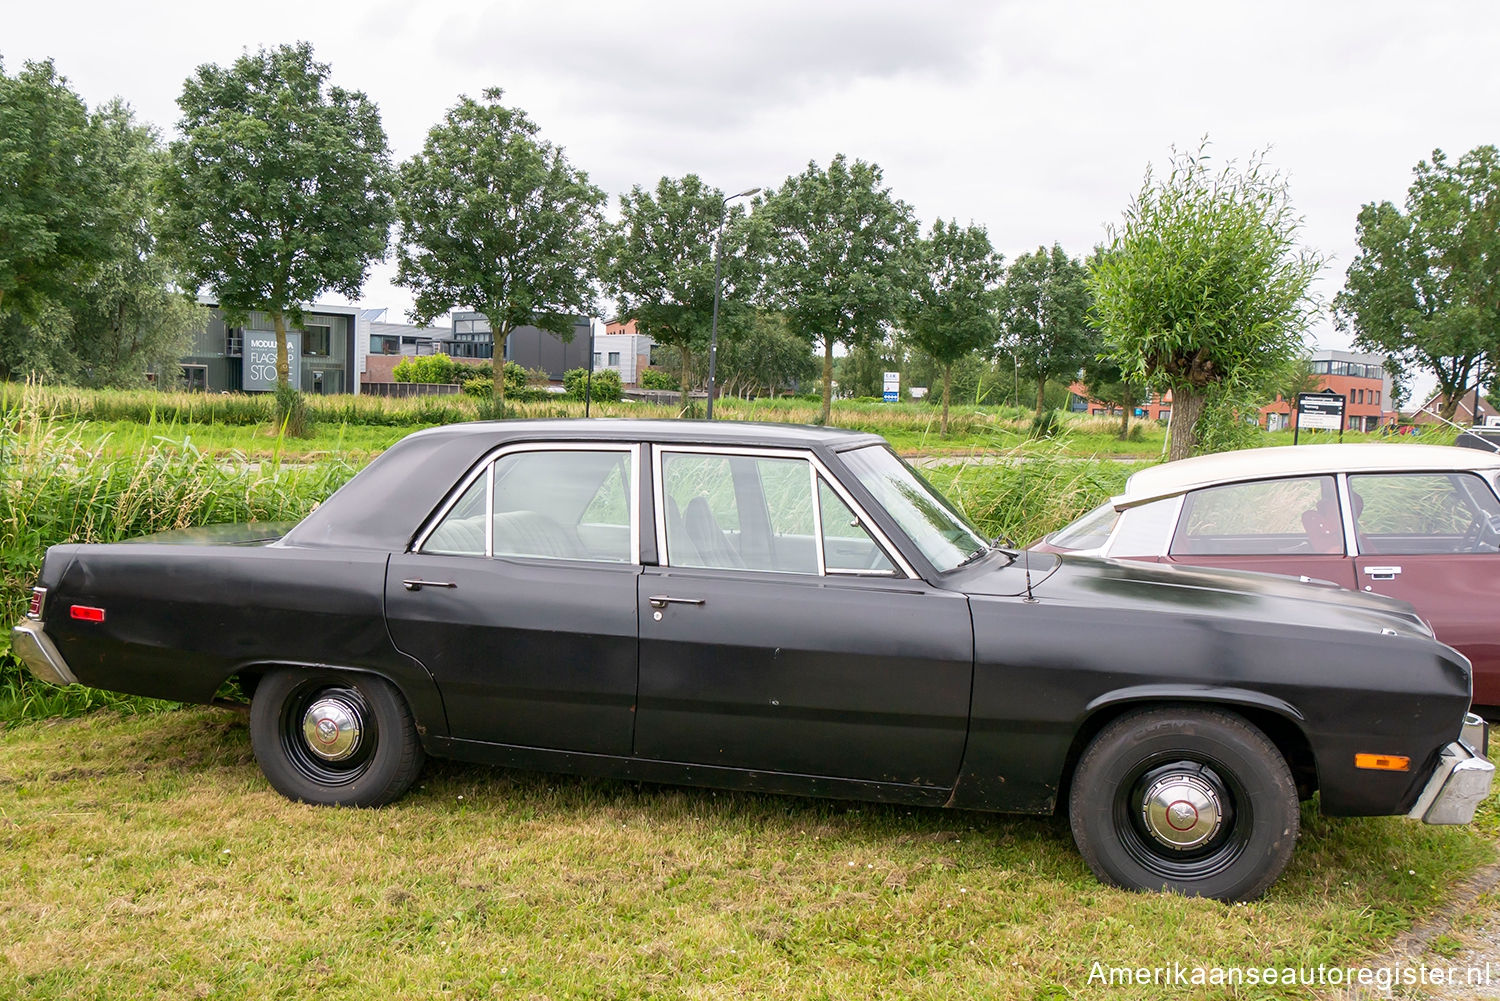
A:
[842,444,990,572]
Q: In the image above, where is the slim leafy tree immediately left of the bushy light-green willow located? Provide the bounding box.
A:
[999,243,1097,414]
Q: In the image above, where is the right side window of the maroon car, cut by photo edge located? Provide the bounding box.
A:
[1349,473,1500,555]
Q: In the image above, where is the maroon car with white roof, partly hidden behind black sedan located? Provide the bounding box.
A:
[1032,443,1500,716]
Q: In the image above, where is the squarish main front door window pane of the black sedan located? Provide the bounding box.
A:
[662,452,818,573]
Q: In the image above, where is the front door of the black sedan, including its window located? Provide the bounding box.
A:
[636,449,974,786]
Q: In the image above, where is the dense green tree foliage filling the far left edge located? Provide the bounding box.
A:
[0,62,204,386]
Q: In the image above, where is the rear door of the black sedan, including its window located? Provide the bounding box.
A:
[386,444,641,755]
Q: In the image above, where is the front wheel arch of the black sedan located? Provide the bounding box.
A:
[1056,684,1319,813]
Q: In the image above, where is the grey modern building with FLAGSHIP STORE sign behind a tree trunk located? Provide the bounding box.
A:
[182,297,369,395]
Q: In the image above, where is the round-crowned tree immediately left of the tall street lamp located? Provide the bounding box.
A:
[600,174,750,408]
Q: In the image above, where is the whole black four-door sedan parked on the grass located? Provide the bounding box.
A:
[14,420,1493,900]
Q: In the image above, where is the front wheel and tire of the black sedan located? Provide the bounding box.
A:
[1068,708,1299,902]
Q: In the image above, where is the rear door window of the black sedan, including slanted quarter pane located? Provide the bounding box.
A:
[422,449,635,563]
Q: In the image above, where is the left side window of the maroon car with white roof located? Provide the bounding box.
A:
[1172,476,1344,555]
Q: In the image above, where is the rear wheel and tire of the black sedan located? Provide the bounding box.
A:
[251,669,423,806]
